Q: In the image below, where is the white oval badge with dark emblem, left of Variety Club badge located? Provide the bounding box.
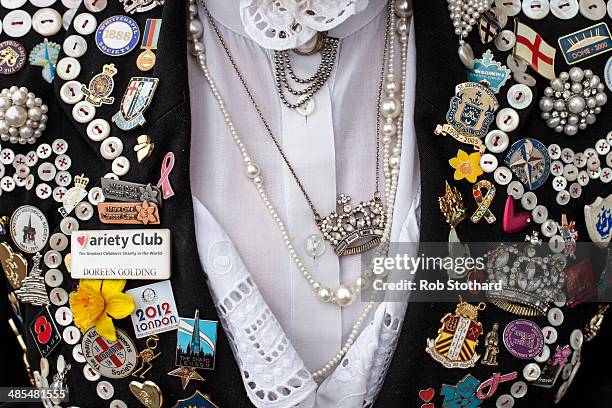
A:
[10,205,49,254]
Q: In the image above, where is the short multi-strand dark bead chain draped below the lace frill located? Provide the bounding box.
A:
[274,33,338,109]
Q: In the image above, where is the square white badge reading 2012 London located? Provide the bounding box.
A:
[126,280,179,339]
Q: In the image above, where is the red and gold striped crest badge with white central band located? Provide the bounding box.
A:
[425,300,486,369]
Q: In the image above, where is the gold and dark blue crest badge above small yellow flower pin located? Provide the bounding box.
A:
[434,82,499,154]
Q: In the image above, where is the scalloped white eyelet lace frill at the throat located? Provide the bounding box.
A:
[240,0,369,50]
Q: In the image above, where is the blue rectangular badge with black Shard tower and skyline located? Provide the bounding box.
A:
[176,309,217,370]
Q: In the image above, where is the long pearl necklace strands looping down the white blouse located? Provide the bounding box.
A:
[188,0,411,381]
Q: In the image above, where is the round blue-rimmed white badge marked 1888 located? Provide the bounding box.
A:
[96,16,140,57]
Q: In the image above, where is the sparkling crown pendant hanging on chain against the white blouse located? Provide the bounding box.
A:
[315,194,387,256]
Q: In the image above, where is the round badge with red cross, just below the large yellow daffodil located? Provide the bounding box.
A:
[81,328,138,378]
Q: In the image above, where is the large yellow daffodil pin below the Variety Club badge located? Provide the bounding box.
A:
[70,279,135,341]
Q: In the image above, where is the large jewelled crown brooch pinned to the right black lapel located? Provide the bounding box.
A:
[485,232,567,316]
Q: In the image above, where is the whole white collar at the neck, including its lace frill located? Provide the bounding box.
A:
[205,0,387,50]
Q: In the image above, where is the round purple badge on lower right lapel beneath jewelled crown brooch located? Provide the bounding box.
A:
[504,319,544,360]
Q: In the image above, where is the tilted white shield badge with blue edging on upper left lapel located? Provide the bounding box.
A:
[113,77,159,130]
